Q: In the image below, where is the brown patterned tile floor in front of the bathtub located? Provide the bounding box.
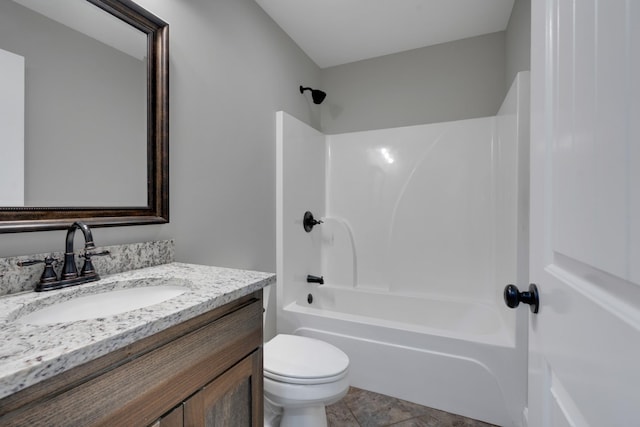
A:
[327,387,493,427]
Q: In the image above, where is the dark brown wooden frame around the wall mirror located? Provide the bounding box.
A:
[0,0,169,233]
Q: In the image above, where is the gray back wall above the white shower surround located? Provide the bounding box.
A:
[321,32,506,134]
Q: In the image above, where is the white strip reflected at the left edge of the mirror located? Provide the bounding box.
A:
[0,49,24,206]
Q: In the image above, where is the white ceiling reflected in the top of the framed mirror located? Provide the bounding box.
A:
[13,0,147,60]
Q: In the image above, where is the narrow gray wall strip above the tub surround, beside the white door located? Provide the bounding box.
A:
[505,0,531,91]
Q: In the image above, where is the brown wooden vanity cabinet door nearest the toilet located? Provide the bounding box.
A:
[184,349,263,427]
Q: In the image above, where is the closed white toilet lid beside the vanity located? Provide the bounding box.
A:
[264,334,349,384]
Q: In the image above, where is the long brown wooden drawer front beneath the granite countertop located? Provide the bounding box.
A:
[0,298,262,426]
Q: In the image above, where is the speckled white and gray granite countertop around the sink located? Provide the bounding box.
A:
[0,263,275,399]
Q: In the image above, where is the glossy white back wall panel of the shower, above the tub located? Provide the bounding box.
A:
[323,117,515,303]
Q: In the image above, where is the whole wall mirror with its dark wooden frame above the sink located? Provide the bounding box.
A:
[0,0,169,233]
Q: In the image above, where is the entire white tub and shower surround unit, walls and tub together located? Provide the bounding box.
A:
[277,73,528,425]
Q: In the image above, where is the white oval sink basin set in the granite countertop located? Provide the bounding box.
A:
[15,285,189,325]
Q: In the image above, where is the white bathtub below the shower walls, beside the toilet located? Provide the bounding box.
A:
[278,285,524,426]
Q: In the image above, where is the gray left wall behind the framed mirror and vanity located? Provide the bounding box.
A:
[0,0,320,271]
